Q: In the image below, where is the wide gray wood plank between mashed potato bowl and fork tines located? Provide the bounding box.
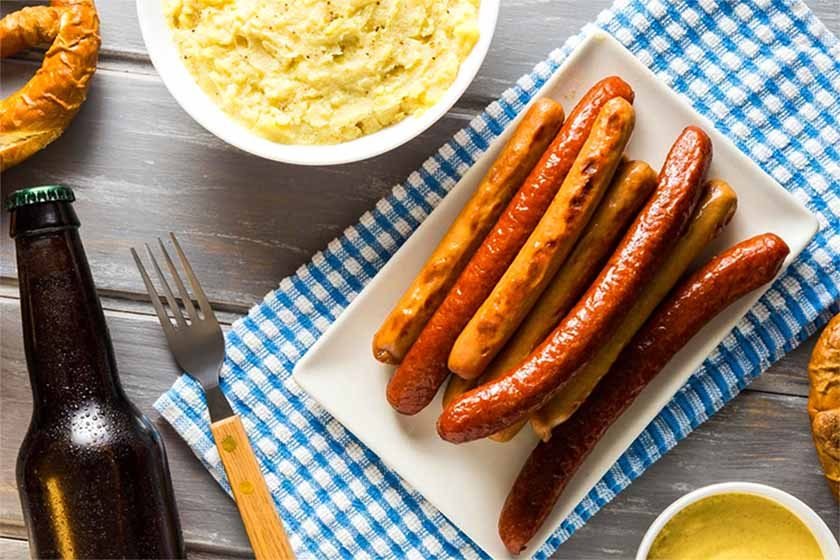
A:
[0,63,466,311]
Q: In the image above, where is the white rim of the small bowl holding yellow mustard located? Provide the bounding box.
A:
[636,482,840,560]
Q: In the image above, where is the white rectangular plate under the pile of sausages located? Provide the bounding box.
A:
[294,32,817,558]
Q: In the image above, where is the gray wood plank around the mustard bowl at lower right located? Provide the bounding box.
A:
[557,391,840,560]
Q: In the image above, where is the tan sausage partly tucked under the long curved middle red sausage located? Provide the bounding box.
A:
[480,161,656,442]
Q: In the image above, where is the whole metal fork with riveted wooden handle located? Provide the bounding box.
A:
[131,233,294,560]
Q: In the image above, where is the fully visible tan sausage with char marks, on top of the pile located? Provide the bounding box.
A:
[449,97,635,379]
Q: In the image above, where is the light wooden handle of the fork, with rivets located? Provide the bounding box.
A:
[210,416,295,560]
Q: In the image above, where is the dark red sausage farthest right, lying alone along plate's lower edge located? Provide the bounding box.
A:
[499,233,789,554]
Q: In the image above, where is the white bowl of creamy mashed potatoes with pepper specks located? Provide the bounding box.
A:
[137,0,499,165]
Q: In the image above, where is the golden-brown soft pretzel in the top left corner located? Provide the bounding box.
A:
[0,0,100,171]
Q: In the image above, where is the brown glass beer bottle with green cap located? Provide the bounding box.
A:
[7,186,185,558]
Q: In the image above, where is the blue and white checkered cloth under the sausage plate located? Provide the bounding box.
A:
[155,0,840,558]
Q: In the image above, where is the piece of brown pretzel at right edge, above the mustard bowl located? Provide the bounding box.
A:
[808,315,840,500]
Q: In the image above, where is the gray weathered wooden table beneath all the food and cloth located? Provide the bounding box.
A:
[0,0,840,558]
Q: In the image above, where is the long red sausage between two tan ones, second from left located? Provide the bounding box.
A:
[386,77,633,414]
